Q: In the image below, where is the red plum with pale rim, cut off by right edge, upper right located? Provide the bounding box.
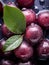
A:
[38,10,49,29]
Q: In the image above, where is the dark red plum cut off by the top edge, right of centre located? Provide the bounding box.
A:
[16,0,35,7]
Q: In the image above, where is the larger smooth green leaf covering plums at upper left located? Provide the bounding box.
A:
[3,5,26,34]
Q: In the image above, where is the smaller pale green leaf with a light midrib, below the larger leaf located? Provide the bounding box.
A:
[3,35,23,52]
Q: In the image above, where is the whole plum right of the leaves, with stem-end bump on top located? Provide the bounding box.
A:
[25,23,43,45]
